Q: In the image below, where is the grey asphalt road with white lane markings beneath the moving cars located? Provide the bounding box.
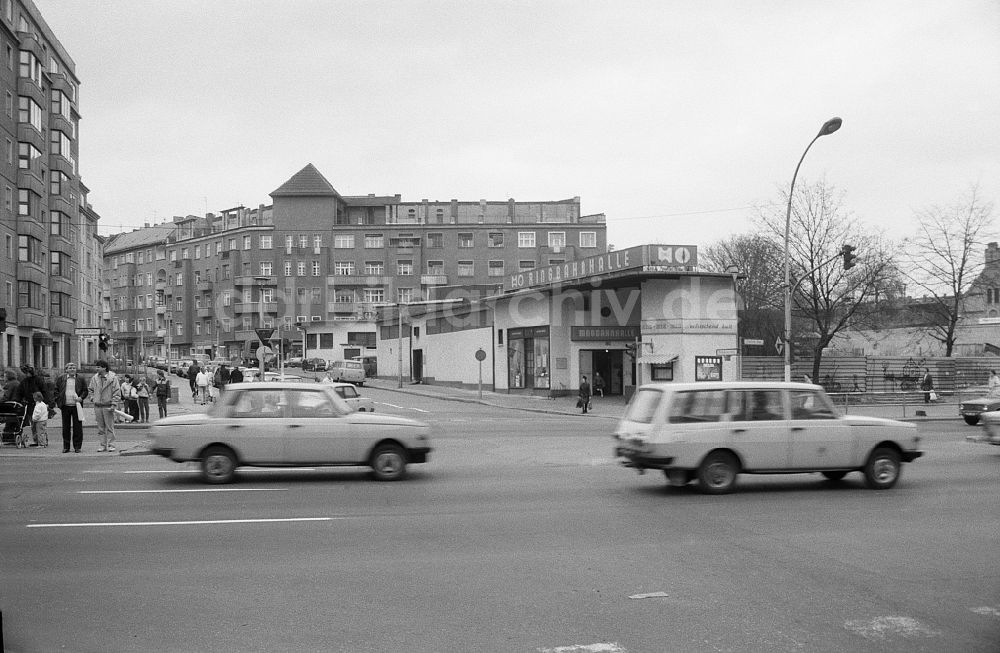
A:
[0,390,1000,653]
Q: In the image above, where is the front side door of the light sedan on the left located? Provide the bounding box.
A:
[284,387,357,465]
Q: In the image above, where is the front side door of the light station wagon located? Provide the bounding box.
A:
[790,389,857,469]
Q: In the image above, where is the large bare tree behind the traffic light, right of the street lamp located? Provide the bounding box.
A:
[759,181,896,382]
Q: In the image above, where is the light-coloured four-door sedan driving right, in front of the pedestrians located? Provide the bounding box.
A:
[152,382,431,483]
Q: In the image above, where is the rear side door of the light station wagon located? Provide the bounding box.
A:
[727,388,791,470]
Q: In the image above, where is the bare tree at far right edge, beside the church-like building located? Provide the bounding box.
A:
[905,186,993,356]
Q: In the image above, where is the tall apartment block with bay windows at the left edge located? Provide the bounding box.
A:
[0,0,101,367]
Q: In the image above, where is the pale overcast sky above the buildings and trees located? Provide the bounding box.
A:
[35,0,1000,249]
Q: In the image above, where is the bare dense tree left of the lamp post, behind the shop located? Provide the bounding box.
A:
[700,233,784,354]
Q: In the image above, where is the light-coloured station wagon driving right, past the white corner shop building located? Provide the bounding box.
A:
[615,382,923,494]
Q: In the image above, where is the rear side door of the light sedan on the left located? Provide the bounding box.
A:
[224,388,285,464]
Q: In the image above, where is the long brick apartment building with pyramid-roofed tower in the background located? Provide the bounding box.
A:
[104,164,607,359]
